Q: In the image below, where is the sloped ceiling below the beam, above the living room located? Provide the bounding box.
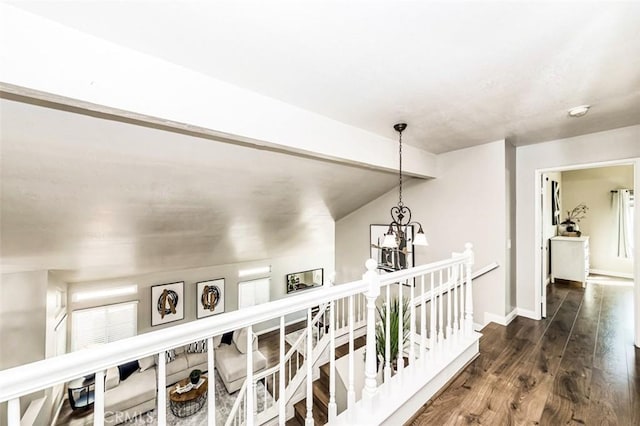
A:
[0,99,397,281]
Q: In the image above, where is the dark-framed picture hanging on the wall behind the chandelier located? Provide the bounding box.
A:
[370,225,415,272]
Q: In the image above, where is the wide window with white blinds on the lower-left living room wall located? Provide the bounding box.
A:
[71,302,138,351]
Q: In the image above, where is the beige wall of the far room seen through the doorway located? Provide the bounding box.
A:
[562,166,633,274]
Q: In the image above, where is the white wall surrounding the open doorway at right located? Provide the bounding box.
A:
[516,126,640,320]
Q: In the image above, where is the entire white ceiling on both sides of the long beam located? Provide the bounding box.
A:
[0,1,640,281]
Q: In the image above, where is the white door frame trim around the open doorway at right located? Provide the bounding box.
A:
[535,159,640,347]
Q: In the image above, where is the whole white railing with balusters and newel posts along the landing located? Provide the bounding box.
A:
[0,244,473,426]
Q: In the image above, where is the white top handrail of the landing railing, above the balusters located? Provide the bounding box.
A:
[0,250,471,402]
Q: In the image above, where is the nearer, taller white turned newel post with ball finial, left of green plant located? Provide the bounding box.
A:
[362,259,380,399]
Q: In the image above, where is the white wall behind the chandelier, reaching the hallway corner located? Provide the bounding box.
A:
[336,140,508,323]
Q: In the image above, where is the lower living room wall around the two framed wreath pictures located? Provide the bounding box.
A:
[69,246,334,334]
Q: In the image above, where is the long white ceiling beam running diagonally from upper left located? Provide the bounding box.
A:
[0,4,437,178]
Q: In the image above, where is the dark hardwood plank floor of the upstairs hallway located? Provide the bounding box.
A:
[409,284,640,426]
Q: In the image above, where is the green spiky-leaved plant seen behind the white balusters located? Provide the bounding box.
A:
[376,297,411,369]
